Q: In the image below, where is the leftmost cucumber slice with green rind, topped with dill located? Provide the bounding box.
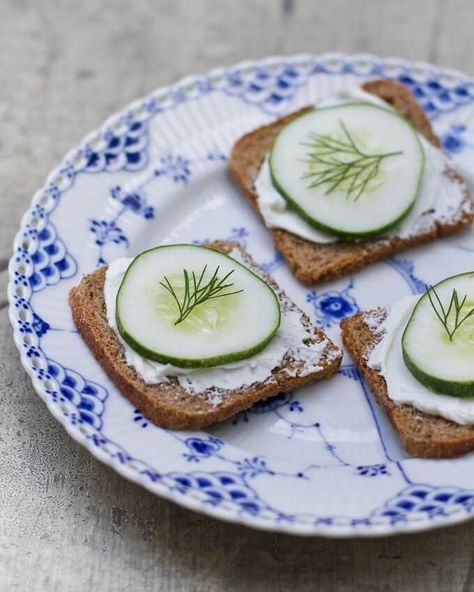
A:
[116,245,280,368]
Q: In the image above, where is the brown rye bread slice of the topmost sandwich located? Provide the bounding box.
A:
[229,80,474,285]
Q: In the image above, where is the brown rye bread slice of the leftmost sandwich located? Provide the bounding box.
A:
[69,242,342,430]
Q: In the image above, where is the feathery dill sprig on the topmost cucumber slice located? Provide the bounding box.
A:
[303,120,402,201]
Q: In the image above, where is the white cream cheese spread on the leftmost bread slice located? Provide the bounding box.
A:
[104,253,334,394]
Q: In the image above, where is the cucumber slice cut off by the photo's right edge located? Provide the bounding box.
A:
[402,272,474,397]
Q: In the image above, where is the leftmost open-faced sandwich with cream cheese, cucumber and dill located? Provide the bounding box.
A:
[69,243,342,429]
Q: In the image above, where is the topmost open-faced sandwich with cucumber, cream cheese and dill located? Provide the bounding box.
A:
[229,80,473,285]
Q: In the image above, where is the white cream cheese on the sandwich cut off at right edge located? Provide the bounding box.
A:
[365,296,474,425]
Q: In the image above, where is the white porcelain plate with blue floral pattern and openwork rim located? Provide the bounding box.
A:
[9,54,474,536]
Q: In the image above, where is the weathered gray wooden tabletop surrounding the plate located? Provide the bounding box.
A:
[0,0,474,592]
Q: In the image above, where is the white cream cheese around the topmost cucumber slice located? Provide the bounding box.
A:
[254,87,464,243]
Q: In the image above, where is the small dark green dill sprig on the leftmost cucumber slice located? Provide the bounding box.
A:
[160,265,243,325]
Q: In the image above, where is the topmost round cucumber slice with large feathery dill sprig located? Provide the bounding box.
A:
[269,103,424,239]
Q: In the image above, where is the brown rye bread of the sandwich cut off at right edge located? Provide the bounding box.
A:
[341,308,474,458]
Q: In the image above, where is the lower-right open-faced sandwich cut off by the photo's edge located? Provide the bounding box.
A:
[341,272,474,458]
